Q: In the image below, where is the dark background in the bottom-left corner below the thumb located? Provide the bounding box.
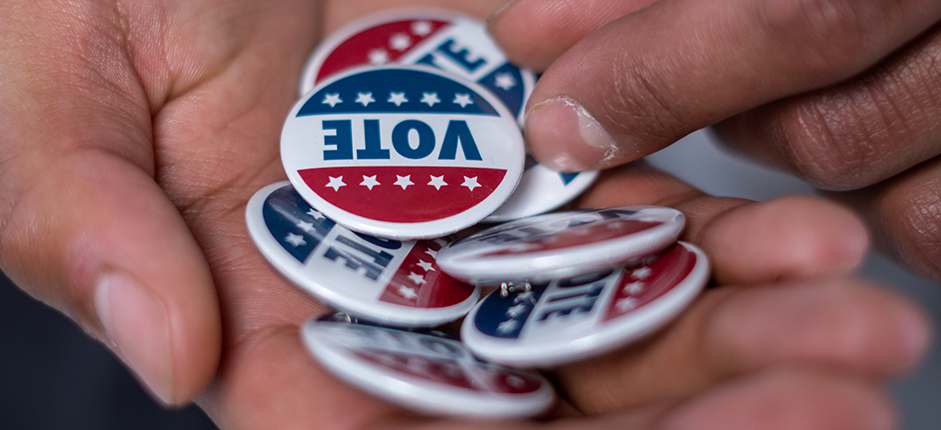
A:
[0,273,216,430]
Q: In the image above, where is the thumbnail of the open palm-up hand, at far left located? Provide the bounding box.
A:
[95,273,173,404]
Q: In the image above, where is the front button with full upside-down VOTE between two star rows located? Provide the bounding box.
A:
[281,66,525,239]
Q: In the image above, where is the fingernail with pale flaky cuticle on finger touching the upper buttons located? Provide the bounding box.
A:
[525,97,618,172]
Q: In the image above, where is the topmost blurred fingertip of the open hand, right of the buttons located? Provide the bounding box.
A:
[700,196,869,283]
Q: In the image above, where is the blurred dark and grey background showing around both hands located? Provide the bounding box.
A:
[0,132,941,430]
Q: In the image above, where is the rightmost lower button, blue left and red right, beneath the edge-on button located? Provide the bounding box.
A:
[461,242,709,367]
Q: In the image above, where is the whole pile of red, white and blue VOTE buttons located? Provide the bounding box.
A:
[246,9,708,418]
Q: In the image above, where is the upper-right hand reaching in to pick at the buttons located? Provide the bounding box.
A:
[490,0,941,280]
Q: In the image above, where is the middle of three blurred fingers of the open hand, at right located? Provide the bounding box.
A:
[703,280,929,378]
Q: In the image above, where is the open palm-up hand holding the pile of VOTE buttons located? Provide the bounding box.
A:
[0,0,927,429]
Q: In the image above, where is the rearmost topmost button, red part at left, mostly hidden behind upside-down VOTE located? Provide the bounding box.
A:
[300,8,536,124]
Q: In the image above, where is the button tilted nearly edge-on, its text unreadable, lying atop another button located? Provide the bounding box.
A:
[438,206,685,283]
